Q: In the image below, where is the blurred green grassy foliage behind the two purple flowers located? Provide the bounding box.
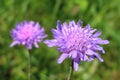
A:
[0,0,120,80]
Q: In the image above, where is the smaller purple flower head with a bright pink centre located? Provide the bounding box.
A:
[10,21,47,49]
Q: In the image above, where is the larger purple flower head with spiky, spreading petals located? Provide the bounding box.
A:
[44,20,109,71]
